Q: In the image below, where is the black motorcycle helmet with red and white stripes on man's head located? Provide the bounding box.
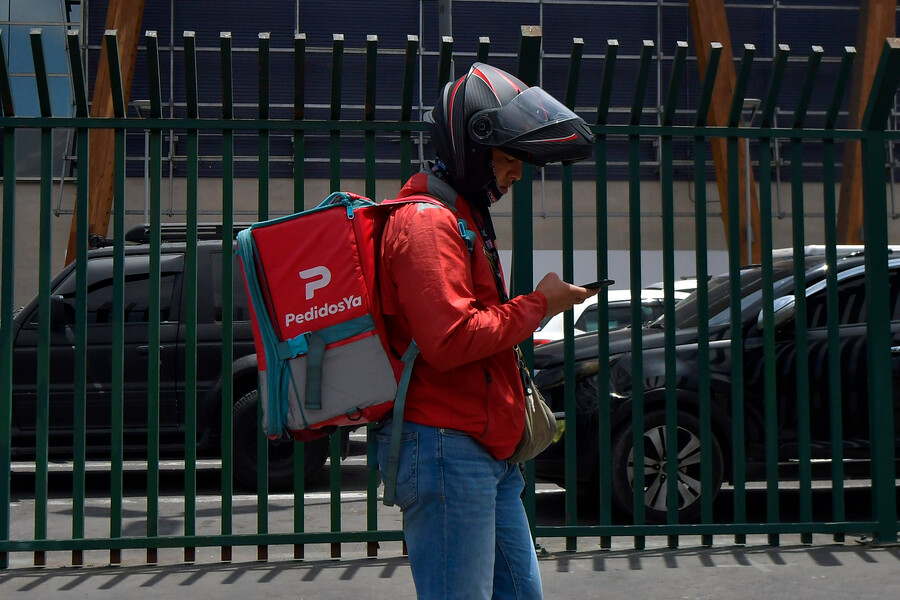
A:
[425,63,594,201]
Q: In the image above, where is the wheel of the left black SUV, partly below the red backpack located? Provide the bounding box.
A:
[232,390,328,491]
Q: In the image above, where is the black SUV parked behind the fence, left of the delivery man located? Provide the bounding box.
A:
[11,226,328,489]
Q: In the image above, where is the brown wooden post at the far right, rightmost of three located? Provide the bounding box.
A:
[837,0,897,244]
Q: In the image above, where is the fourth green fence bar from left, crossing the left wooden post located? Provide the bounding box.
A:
[104,31,126,565]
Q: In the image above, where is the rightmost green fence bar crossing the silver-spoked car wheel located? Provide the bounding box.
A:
[694,42,724,546]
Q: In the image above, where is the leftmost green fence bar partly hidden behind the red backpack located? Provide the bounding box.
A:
[256,33,269,561]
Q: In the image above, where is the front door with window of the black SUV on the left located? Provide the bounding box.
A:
[16,254,183,446]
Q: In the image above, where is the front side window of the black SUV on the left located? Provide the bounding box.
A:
[30,256,180,326]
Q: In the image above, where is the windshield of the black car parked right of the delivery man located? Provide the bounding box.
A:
[652,263,793,329]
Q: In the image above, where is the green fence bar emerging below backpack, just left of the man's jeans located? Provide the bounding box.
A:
[364,35,379,557]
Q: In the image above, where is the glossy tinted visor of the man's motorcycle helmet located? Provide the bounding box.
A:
[469,87,580,146]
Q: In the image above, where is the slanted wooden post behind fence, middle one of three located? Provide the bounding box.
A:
[688,0,761,265]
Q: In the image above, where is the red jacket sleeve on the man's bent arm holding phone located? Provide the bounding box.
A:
[384,204,547,370]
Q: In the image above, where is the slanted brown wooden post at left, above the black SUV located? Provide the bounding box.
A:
[66,0,145,264]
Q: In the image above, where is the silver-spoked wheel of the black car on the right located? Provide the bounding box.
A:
[612,410,724,523]
